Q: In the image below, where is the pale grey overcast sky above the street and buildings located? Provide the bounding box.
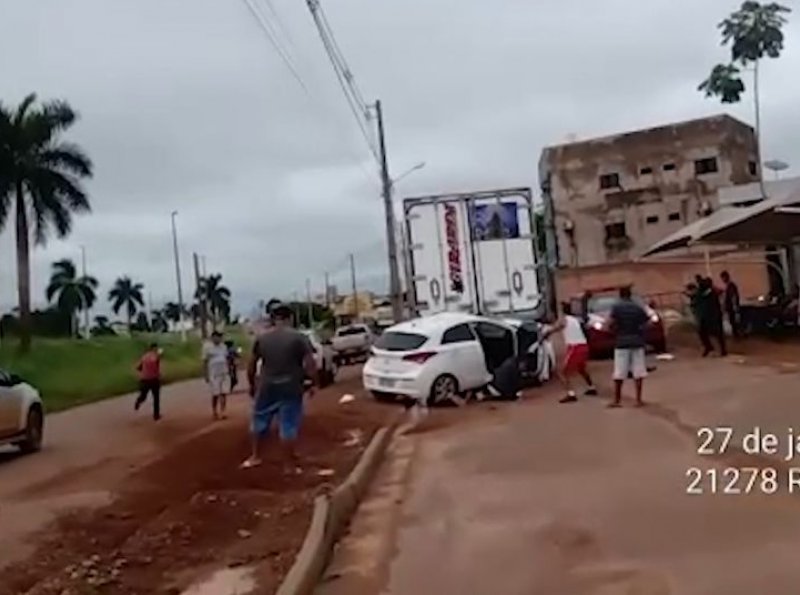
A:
[0,0,800,312]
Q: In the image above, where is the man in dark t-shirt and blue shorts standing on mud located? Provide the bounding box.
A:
[242,304,317,471]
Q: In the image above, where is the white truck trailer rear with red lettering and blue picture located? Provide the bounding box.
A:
[403,188,553,318]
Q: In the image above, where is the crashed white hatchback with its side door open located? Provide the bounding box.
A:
[363,312,555,404]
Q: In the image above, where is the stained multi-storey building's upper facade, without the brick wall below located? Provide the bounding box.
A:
[539,115,758,267]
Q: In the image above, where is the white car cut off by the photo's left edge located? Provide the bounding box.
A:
[0,370,44,452]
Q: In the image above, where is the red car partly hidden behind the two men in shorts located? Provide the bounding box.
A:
[571,295,667,357]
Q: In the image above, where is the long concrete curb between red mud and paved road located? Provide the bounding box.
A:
[276,426,395,595]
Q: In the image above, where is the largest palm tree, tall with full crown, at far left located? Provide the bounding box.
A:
[0,94,92,351]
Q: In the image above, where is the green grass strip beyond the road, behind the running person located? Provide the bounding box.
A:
[0,334,243,412]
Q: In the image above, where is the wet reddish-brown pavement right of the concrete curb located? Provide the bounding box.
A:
[320,360,800,595]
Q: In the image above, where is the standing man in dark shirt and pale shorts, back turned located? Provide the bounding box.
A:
[609,287,648,407]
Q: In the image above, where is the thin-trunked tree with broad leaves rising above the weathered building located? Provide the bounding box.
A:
[698,1,791,179]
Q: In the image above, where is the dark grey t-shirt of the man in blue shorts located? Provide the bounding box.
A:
[253,327,313,397]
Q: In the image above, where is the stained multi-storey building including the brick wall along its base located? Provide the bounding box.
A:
[539,115,767,306]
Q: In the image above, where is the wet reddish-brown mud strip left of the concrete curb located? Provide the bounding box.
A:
[0,378,398,595]
